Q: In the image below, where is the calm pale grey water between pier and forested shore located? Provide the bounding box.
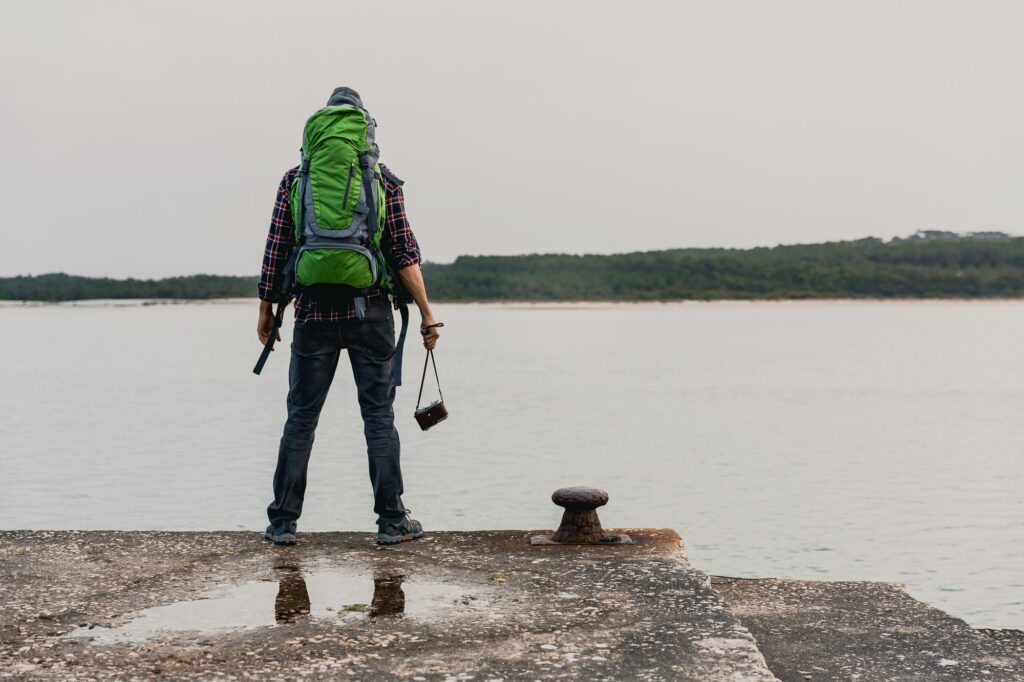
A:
[0,302,1024,628]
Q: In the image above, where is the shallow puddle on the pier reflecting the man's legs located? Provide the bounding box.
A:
[63,566,494,644]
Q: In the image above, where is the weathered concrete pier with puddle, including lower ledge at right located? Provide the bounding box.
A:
[0,528,1024,681]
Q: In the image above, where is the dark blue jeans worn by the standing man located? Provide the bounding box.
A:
[266,299,406,532]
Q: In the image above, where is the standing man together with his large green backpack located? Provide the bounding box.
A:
[255,88,440,545]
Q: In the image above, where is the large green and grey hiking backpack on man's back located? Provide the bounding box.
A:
[291,88,392,299]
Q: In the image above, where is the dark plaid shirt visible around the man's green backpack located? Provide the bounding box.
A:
[259,167,421,323]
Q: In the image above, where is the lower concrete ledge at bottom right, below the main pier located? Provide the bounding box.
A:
[712,577,1024,682]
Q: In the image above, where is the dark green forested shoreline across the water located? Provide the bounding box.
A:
[8,232,1024,301]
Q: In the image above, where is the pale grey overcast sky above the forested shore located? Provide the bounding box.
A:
[0,0,1024,276]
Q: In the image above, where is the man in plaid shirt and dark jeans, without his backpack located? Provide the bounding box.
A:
[256,88,439,545]
